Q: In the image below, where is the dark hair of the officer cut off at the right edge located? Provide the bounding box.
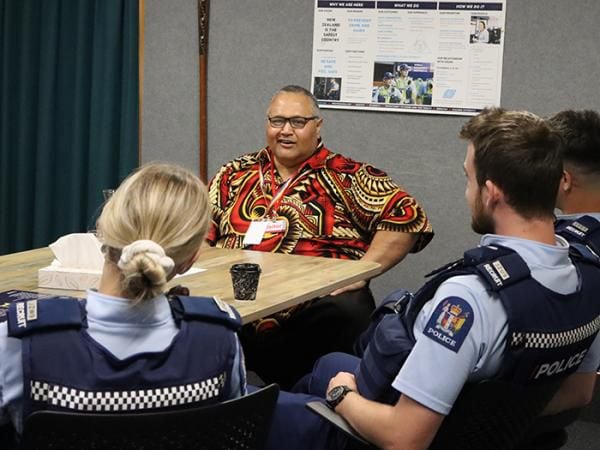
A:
[548,110,600,176]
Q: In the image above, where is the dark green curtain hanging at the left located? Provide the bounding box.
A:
[0,0,139,254]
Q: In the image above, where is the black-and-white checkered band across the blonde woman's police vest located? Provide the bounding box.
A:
[31,373,225,412]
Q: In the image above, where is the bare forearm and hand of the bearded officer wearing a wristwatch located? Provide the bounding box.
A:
[329,372,445,450]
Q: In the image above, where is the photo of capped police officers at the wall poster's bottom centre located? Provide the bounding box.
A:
[371,61,434,105]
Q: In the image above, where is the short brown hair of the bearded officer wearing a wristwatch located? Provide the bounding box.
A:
[460,108,563,218]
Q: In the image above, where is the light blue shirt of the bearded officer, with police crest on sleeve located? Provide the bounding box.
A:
[392,235,600,415]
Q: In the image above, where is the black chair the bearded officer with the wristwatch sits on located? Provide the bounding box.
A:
[307,380,564,450]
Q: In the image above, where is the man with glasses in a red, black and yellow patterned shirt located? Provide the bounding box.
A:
[208,86,433,388]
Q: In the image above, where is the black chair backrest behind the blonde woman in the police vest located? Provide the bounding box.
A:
[21,384,279,450]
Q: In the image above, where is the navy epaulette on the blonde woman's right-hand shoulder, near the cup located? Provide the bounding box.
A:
[169,295,242,330]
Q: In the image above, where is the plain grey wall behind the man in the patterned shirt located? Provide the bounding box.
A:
[143,0,600,302]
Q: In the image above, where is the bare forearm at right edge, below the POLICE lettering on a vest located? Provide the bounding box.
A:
[542,372,598,416]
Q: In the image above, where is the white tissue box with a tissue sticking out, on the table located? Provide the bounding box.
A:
[38,233,104,290]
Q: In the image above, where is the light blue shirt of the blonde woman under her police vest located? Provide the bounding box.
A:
[0,290,246,432]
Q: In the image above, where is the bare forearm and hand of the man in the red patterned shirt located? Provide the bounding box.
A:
[330,230,419,295]
